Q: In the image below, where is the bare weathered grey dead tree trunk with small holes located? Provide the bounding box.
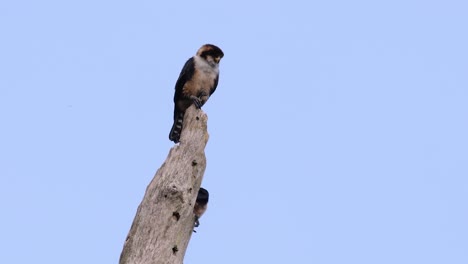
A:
[120,106,208,264]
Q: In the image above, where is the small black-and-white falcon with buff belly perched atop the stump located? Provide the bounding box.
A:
[169,44,224,143]
